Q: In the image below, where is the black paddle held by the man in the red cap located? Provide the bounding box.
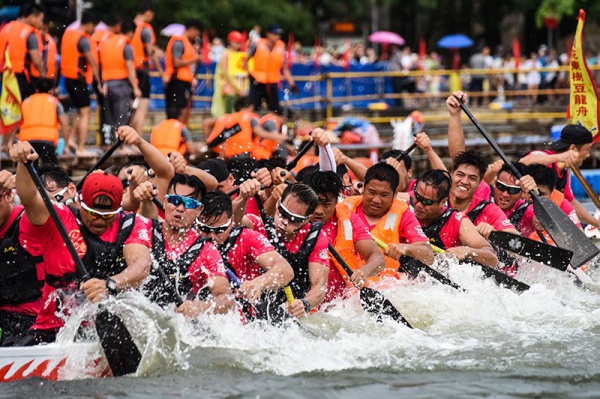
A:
[25,162,142,377]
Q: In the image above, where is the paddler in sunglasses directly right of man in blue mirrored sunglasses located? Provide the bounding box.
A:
[196,191,294,319]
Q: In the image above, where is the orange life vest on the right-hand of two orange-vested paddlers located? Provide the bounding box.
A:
[342,195,408,276]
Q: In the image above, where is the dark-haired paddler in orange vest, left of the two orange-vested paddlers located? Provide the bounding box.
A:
[304,171,385,302]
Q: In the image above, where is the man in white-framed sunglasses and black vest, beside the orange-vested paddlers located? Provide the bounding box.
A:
[240,183,329,319]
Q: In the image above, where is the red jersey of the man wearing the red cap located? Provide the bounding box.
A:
[21,204,151,330]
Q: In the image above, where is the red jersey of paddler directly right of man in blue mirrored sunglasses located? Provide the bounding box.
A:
[221,229,275,282]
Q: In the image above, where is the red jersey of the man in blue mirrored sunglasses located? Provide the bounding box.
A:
[163,226,227,294]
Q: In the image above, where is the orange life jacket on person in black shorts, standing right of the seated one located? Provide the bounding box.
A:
[60,30,93,84]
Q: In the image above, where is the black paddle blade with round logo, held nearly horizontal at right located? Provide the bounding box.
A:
[489,231,573,271]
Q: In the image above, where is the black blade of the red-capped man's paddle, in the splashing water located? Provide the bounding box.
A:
[96,309,142,377]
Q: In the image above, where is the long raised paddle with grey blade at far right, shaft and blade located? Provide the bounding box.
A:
[458,99,600,269]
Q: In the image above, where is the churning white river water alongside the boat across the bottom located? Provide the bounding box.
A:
[0,260,600,398]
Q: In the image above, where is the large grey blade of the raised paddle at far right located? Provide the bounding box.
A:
[533,195,600,269]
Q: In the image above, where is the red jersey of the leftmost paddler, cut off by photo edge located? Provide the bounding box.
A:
[0,205,45,316]
